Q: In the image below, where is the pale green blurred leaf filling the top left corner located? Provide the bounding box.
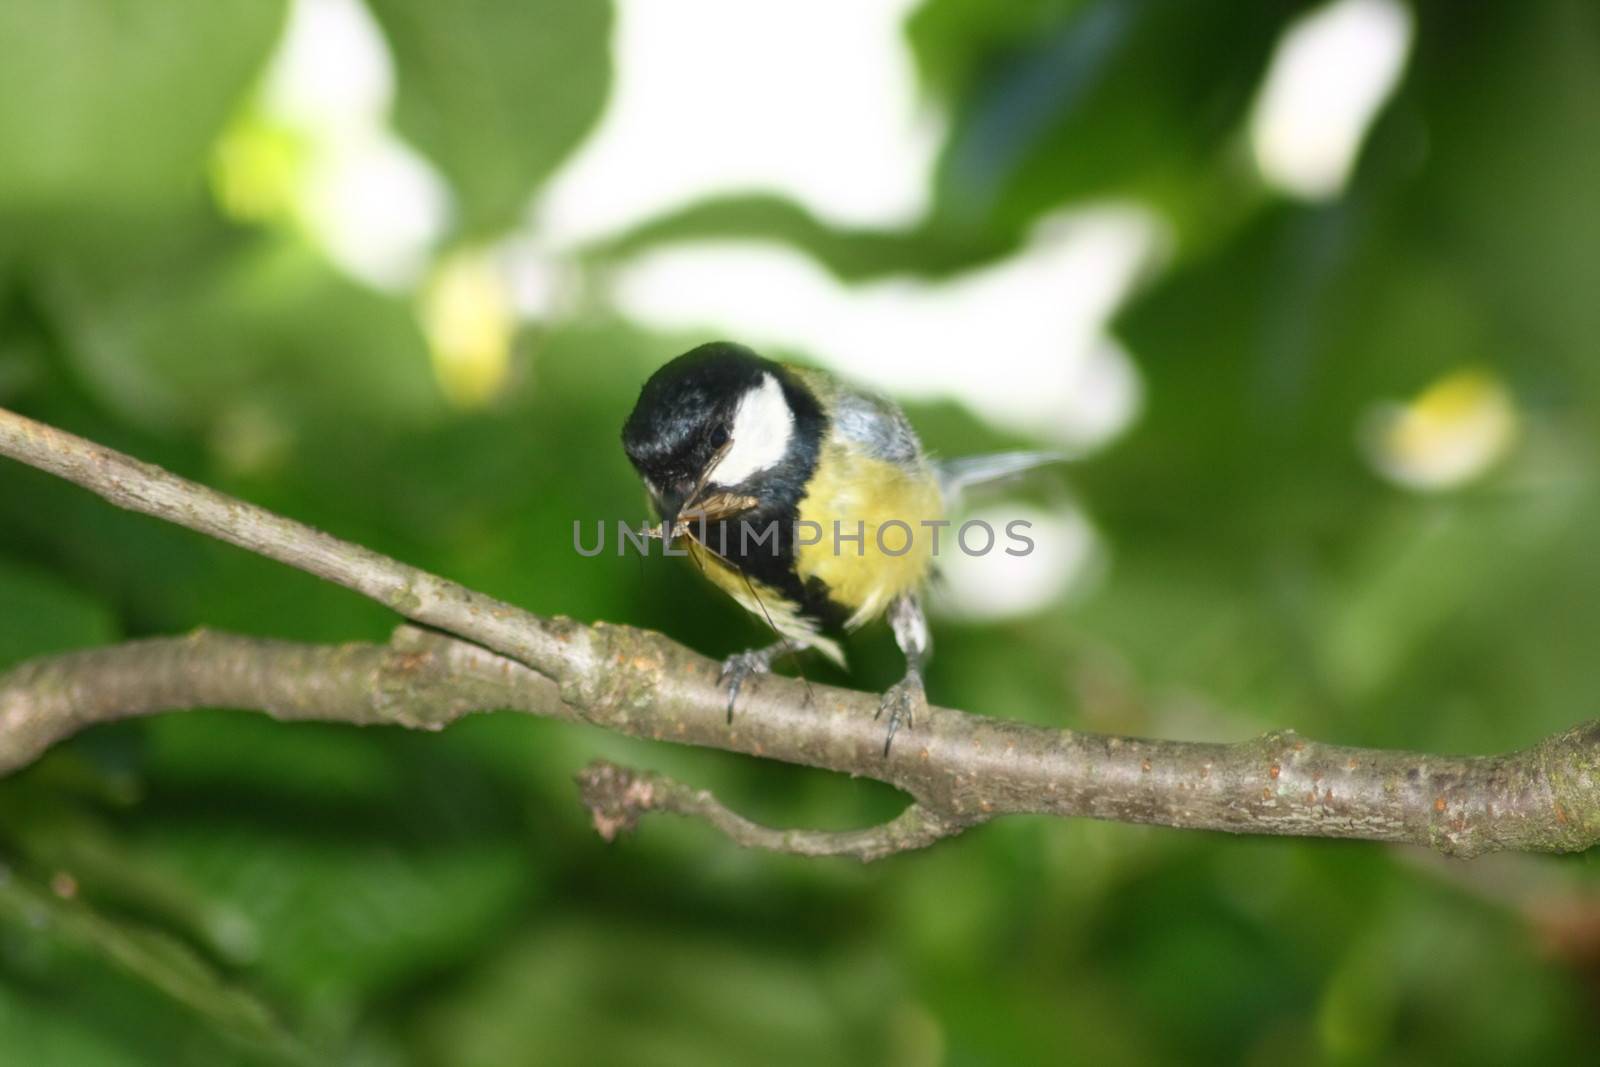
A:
[0,0,285,230]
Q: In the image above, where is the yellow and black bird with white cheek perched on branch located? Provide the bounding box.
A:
[622,341,1064,757]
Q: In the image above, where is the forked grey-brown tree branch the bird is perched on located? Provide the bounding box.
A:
[0,410,1600,859]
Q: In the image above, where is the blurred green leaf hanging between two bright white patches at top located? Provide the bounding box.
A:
[368,0,611,232]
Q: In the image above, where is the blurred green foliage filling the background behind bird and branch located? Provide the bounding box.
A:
[0,0,1600,1067]
